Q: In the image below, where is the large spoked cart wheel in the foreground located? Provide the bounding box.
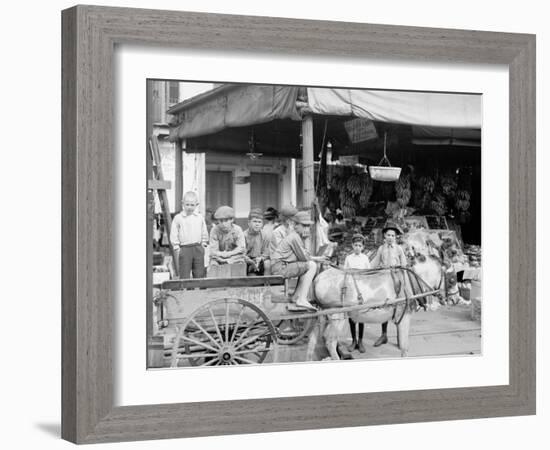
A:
[171,298,276,367]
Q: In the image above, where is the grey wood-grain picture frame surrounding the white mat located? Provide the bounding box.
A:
[62,6,536,443]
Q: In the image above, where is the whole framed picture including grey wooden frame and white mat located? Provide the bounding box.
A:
[62,6,536,443]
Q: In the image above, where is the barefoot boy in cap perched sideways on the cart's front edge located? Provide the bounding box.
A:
[271,211,326,311]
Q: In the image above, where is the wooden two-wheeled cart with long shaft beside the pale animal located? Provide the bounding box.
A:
[154,266,439,367]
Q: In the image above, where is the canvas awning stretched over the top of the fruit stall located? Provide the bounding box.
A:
[168,85,481,140]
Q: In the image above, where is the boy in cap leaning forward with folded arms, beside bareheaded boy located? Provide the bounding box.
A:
[210,206,246,265]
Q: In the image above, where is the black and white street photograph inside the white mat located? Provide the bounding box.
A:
[147,80,482,368]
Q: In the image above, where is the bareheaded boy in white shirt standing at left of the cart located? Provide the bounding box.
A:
[170,191,208,278]
